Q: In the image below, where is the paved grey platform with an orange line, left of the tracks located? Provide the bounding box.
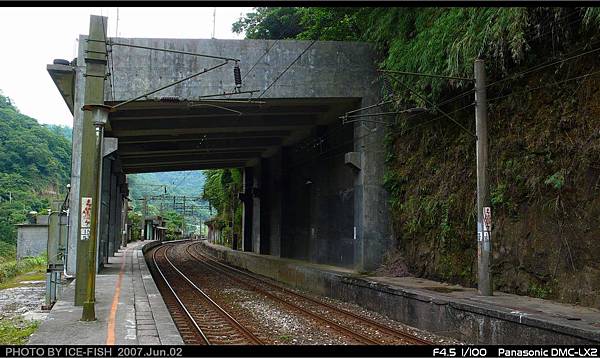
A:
[28,241,183,345]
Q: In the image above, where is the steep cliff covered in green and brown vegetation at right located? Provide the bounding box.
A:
[234,7,600,307]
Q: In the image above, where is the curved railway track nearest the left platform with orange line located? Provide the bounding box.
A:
[152,244,262,345]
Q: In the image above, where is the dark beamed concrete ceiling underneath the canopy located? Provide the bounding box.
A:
[105,98,358,173]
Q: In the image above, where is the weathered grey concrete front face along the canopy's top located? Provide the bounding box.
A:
[106,38,376,100]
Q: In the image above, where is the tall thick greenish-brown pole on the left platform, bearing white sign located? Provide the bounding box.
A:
[75,16,108,321]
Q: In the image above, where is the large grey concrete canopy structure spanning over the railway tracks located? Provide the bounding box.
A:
[48,16,391,300]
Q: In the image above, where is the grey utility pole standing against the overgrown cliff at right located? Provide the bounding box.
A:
[474,60,493,296]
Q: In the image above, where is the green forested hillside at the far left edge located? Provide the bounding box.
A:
[0,94,71,256]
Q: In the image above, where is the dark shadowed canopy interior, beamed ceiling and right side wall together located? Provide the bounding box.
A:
[105,98,360,267]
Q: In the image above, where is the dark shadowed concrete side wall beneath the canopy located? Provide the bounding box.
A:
[248,121,356,267]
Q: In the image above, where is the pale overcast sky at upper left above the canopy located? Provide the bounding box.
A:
[0,7,252,126]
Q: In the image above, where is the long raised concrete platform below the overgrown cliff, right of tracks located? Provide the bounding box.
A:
[202,241,600,344]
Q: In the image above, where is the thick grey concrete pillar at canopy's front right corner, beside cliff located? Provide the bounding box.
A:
[353,92,393,272]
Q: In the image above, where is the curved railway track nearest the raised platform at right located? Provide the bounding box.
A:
[185,243,432,344]
